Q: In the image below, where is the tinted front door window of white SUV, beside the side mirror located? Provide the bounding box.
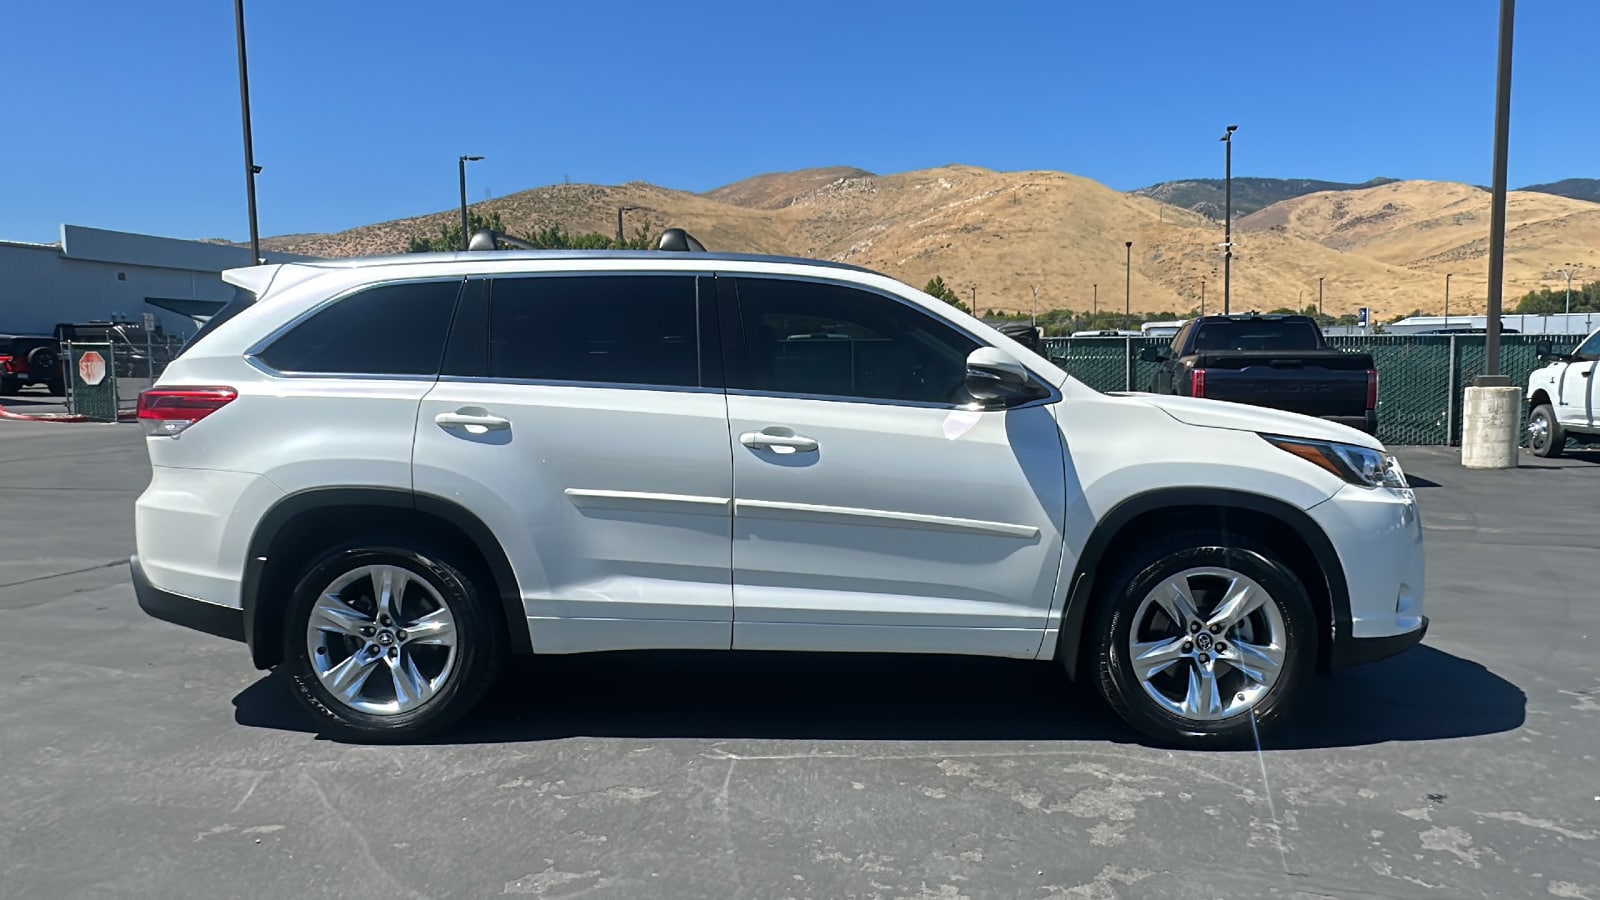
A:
[738,279,979,404]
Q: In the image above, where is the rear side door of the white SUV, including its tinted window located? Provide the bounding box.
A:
[414,272,733,653]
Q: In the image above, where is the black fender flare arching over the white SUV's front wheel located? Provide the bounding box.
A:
[1056,487,1350,676]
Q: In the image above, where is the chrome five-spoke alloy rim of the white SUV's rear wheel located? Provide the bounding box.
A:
[306,565,456,716]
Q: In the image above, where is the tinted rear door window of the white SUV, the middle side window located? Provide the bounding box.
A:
[490,275,701,388]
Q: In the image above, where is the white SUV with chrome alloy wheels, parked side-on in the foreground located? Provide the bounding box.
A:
[131,238,1427,746]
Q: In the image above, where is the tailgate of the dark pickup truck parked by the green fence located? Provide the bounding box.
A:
[1194,351,1373,416]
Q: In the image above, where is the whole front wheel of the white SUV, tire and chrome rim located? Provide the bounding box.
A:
[1098,532,1317,748]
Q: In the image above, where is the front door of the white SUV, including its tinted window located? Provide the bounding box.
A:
[720,277,1066,657]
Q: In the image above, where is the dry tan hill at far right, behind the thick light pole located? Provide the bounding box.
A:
[1238,181,1600,312]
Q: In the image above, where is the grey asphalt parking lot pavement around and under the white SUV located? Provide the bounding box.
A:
[0,423,1600,900]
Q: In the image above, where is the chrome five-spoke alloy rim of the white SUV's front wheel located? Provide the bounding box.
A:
[1128,567,1288,722]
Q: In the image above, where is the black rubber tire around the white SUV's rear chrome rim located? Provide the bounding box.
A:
[283,538,504,743]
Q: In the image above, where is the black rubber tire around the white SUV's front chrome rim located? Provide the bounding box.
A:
[1094,530,1317,749]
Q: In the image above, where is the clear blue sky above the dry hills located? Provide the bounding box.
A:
[0,0,1600,240]
